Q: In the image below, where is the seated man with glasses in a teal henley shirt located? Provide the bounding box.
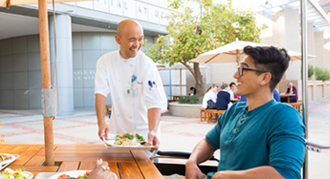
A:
[186,46,305,179]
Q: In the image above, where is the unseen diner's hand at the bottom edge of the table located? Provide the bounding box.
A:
[87,162,115,179]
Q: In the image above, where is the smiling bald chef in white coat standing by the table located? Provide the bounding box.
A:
[95,20,167,152]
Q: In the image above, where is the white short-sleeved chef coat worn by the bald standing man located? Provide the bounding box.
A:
[95,50,167,139]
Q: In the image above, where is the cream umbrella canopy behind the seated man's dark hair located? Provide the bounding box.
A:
[191,40,315,64]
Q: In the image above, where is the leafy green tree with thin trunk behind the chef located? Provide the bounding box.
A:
[146,0,267,100]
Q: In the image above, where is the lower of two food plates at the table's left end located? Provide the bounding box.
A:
[1,167,34,179]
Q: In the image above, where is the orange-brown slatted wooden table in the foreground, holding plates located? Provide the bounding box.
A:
[0,144,163,179]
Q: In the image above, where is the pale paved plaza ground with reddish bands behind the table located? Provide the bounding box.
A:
[0,99,330,179]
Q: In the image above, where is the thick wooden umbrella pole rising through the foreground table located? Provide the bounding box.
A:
[38,0,55,166]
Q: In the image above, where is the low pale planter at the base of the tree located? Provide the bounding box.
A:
[168,102,202,118]
